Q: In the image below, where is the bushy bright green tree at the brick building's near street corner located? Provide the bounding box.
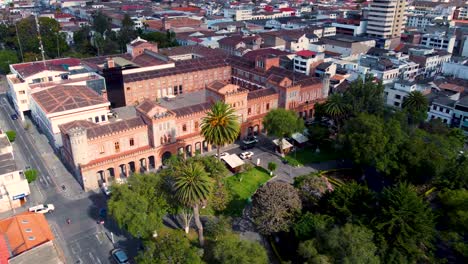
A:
[108,174,168,239]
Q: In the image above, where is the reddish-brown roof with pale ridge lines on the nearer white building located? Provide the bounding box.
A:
[31,85,109,114]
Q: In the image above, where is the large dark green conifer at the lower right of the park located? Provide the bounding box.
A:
[371,183,435,263]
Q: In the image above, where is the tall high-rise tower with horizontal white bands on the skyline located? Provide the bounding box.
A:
[366,0,407,48]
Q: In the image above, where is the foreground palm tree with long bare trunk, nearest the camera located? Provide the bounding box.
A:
[174,161,213,246]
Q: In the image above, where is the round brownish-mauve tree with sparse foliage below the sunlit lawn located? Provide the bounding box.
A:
[252,182,302,235]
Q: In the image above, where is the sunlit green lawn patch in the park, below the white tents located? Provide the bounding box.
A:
[223,167,270,216]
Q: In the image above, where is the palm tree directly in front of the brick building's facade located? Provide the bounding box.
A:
[201,101,240,158]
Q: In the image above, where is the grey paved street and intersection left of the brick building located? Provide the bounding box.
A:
[0,95,136,264]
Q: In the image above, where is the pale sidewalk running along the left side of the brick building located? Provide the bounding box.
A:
[26,119,88,200]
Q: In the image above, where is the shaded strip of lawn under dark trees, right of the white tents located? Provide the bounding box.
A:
[285,147,341,166]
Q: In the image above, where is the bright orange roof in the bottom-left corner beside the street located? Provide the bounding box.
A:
[0,212,54,256]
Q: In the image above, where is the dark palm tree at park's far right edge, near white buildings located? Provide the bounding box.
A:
[402,91,429,124]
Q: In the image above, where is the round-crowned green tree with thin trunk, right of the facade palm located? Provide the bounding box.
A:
[263,108,304,153]
